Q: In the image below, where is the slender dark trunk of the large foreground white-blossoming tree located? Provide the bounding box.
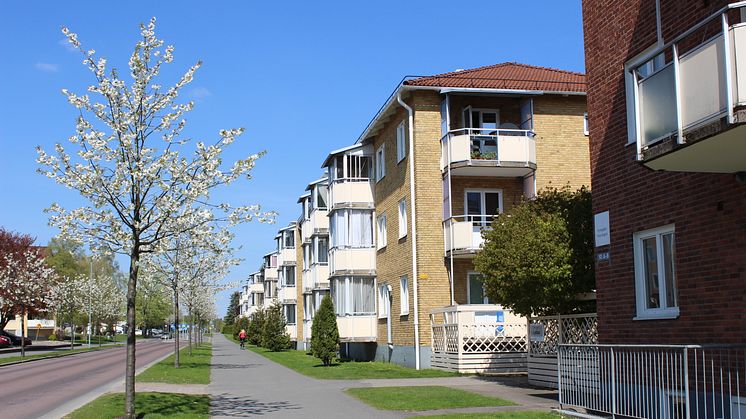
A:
[124,249,140,419]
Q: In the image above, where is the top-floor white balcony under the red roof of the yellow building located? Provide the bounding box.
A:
[440,128,536,177]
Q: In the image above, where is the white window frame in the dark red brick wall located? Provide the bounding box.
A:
[632,224,679,320]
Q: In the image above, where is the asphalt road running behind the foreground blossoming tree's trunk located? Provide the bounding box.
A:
[0,339,174,418]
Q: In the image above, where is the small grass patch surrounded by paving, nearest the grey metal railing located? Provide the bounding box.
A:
[347,386,514,412]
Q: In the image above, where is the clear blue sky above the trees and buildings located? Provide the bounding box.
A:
[0,0,584,316]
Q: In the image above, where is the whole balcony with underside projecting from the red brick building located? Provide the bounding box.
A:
[631,3,746,173]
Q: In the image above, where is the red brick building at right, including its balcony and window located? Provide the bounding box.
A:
[583,0,746,344]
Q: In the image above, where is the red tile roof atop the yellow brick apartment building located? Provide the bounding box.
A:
[404,63,586,93]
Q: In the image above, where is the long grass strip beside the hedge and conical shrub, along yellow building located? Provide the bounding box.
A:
[246,345,457,380]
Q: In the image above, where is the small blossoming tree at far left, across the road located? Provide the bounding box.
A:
[0,249,55,356]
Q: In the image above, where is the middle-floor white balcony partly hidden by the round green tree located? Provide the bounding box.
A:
[443,215,495,258]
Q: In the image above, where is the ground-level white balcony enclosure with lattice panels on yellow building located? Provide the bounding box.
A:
[430,304,527,373]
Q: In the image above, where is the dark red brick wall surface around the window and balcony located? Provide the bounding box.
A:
[583,0,746,344]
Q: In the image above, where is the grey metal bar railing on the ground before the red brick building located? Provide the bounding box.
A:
[558,345,746,418]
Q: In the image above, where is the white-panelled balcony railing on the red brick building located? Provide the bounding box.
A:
[631,2,746,154]
